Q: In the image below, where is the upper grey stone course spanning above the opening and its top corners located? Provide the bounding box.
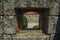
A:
[4,0,59,15]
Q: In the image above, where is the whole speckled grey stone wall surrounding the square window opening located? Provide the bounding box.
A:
[0,0,59,40]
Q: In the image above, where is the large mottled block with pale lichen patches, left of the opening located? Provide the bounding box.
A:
[4,16,17,34]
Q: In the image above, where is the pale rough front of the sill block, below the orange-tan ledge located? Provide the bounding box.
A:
[13,33,49,40]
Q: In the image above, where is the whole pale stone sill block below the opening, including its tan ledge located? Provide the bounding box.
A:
[13,29,49,40]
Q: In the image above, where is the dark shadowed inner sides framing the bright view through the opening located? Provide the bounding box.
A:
[15,8,49,32]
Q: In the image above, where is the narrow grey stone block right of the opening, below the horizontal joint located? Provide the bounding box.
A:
[48,16,58,34]
